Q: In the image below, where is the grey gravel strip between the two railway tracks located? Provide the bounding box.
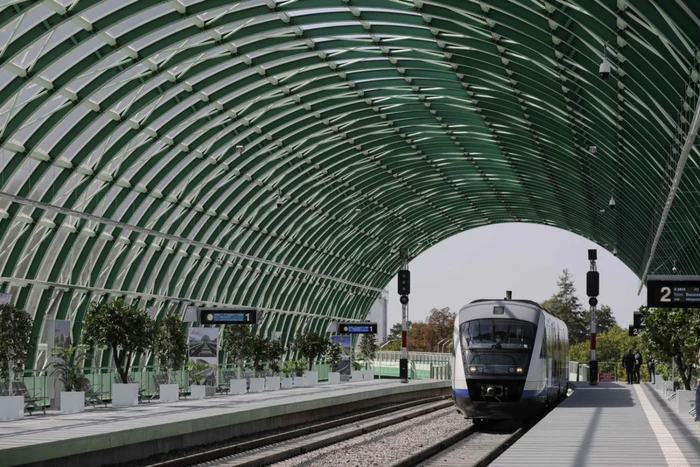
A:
[274,407,471,467]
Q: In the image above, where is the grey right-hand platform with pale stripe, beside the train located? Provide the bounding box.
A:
[490,383,700,467]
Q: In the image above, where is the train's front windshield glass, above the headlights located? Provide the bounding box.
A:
[461,319,536,349]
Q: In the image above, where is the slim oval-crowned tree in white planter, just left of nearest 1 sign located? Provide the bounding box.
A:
[153,313,187,402]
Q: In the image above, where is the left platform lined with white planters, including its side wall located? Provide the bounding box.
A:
[0,380,451,467]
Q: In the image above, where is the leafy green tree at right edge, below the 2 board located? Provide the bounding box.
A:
[639,307,700,391]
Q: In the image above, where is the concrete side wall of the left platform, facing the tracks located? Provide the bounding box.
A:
[0,381,451,467]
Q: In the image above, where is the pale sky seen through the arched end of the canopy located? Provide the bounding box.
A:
[387,224,646,328]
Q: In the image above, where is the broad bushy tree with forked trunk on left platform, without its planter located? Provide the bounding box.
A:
[83,298,155,384]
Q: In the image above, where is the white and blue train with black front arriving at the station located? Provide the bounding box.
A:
[452,299,569,422]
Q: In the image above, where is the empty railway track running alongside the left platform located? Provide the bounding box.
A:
[149,396,454,467]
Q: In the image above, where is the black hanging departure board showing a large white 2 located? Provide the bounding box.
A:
[647,276,700,308]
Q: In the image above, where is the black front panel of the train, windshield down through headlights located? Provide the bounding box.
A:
[460,319,537,376]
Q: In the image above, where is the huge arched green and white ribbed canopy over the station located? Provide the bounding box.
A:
[0,0,700,372]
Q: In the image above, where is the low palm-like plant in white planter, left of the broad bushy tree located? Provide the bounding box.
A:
[51,346,89,413]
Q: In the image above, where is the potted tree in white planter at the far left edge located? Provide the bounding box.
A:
[0,304,34,420]
